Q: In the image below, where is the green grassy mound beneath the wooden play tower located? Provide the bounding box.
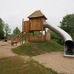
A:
[12,41,64,56]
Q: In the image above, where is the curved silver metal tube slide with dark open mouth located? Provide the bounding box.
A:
[44,22,74,57]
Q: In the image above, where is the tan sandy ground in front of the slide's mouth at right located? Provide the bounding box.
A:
[33,52,74,74]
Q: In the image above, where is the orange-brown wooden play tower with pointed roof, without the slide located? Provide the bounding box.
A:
[22,10,47,42]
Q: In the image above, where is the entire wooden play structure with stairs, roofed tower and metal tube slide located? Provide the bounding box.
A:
[11,10,74,56]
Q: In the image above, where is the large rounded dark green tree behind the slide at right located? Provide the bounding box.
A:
[60,14,74,39]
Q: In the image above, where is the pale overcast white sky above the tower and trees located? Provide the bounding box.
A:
[0,0,74,30]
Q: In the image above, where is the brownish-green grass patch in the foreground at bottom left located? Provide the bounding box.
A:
[0,57,58,74]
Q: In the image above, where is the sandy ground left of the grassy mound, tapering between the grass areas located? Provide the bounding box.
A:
[0,41,30,60]
